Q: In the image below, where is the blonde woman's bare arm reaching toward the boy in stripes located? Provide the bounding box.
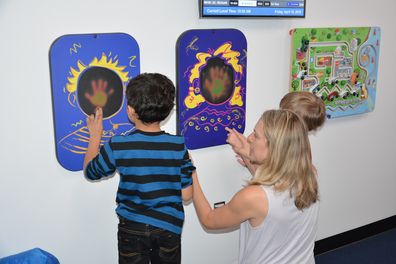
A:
[192,171,267,229]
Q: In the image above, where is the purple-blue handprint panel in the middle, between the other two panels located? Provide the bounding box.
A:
[176,29,247,149]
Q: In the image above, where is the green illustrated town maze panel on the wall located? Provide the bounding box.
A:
[290,27,381,118]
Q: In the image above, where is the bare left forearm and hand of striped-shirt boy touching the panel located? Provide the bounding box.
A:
[83,107,103,171]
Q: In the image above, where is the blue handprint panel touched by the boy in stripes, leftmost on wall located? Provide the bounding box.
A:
[49,33,140,171]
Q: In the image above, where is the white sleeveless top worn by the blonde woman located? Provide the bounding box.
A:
[239,186,319,264]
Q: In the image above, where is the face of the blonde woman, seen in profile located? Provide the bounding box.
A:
[248,119,268,164]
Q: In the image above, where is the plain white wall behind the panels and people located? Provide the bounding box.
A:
[0,0,396,264]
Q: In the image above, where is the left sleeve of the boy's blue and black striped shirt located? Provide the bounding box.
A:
[85,140,116,180]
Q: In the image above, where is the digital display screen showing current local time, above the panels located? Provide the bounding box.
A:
[200,0,305,18]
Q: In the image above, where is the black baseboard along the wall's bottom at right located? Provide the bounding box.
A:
[314,215,396,255]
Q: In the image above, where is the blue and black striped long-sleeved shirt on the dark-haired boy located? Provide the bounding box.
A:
[85,130,195,234]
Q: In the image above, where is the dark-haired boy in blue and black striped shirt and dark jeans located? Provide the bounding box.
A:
[84,73,195,264]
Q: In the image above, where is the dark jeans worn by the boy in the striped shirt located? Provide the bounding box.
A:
[118,217,181,264]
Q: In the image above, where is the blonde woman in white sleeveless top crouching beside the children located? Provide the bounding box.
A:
[193,110,319,264]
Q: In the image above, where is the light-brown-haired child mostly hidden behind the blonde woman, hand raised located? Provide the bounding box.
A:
[226,91,326,175]
